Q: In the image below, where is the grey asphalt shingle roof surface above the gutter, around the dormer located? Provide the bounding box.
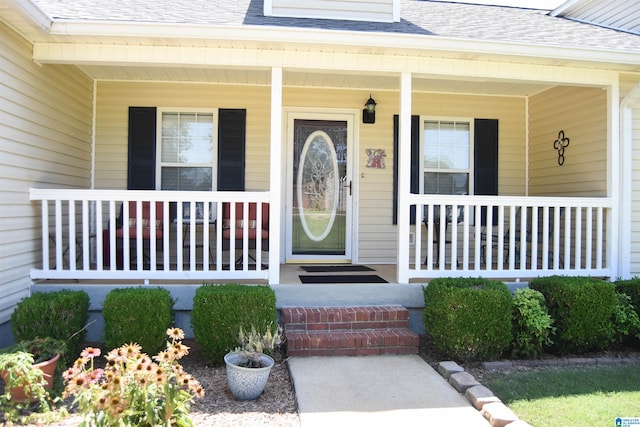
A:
[34,0,640,52]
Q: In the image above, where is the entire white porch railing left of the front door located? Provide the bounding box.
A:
[30,188,270,281]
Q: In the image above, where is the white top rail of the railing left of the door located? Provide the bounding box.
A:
[29,188,271,202]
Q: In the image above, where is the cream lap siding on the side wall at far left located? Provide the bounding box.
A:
[0,22,93,324]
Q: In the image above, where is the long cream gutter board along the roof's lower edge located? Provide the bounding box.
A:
[50,21,640,70]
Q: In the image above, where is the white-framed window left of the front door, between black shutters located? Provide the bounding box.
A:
[156,109,217,191]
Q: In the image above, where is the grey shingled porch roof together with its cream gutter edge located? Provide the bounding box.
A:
[5,0,640,71]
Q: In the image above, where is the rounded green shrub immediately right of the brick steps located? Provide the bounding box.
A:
[423,278,512,362]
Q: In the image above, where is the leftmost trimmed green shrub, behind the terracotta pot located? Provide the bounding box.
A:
[11,290,89,354]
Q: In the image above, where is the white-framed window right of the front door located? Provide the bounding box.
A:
[420,119,473,194]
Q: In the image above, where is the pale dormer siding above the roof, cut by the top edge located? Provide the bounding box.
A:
[265,0,400,22]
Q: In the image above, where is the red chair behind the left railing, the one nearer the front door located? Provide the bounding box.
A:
[222,202,269,264]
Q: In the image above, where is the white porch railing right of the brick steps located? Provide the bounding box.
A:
[408,194,613,279]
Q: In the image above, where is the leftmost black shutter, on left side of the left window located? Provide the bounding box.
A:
[127,107,156,190]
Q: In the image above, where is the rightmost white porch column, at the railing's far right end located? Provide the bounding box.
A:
[607,77,620,280]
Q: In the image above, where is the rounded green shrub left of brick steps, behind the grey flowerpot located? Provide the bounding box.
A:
[191,283,277,365]
